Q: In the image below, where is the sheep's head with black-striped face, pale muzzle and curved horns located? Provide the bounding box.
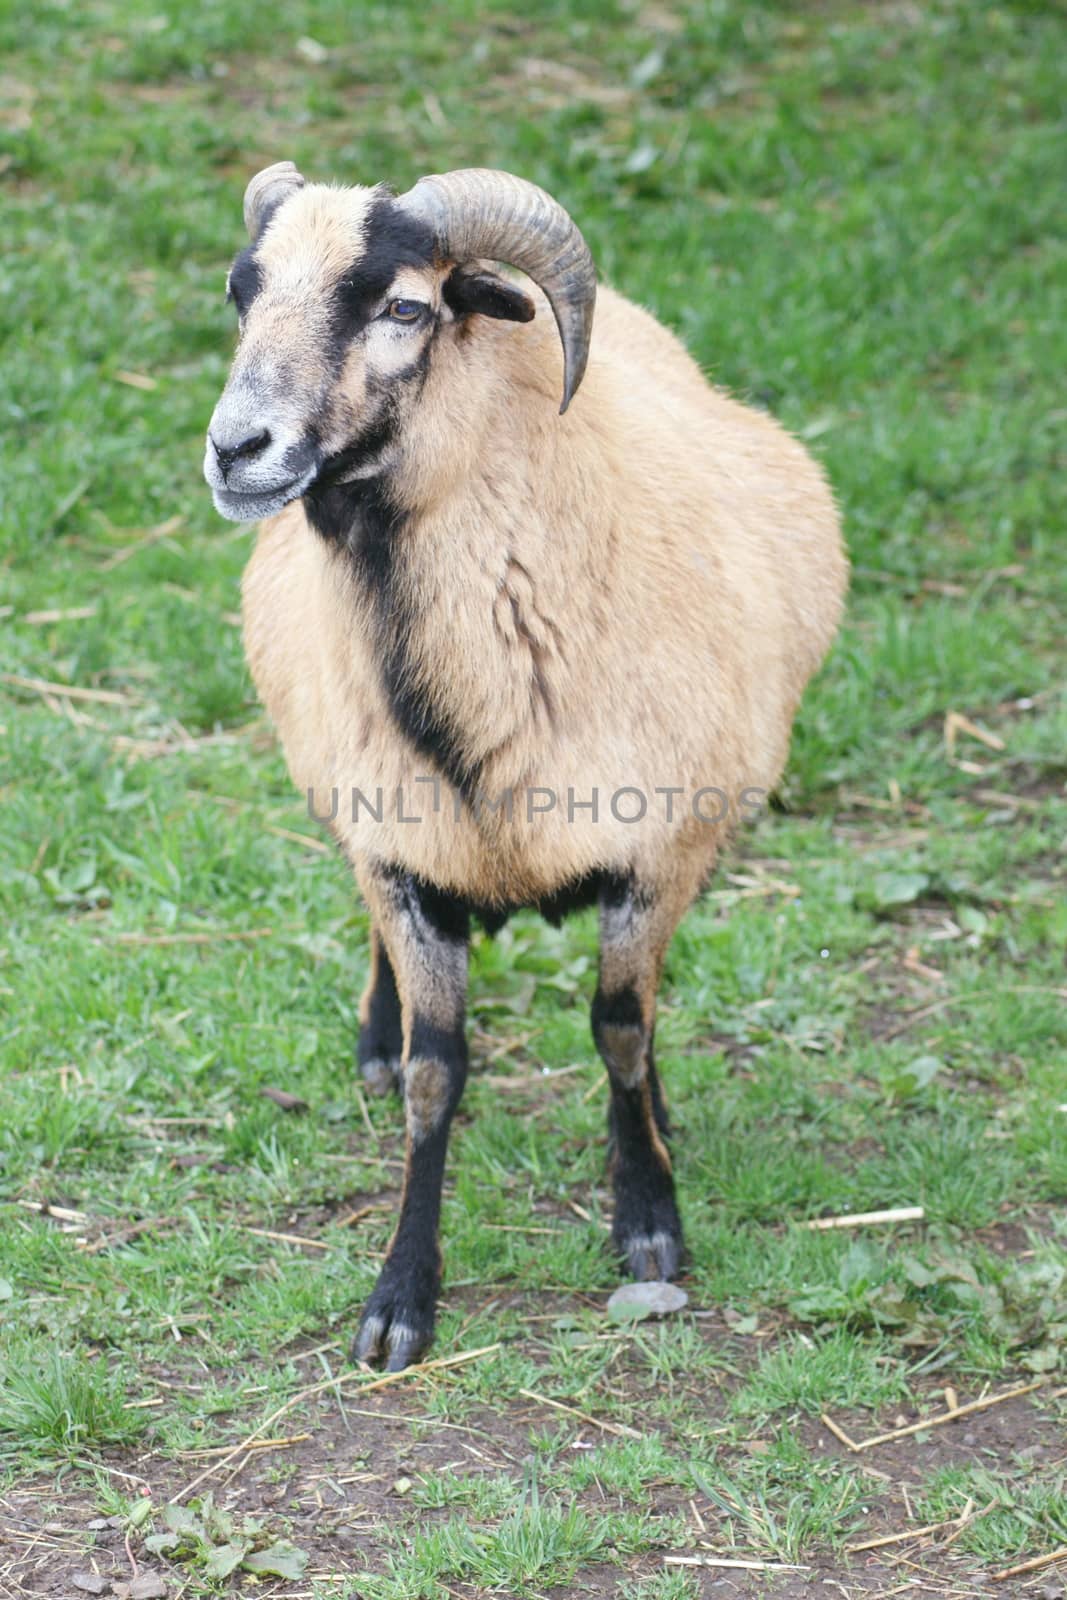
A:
[203,162,597,522]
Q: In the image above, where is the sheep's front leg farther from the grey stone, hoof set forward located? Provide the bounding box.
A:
[352,867,469,1371]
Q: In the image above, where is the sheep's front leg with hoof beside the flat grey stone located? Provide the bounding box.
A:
[592,880,683,1278]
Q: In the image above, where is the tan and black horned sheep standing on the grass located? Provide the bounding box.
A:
[205,162,846,1370]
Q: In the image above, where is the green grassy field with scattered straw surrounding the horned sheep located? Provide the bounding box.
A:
[0,0,1067,1600]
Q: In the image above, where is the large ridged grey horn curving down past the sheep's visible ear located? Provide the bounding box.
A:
[397,166,597,411]
